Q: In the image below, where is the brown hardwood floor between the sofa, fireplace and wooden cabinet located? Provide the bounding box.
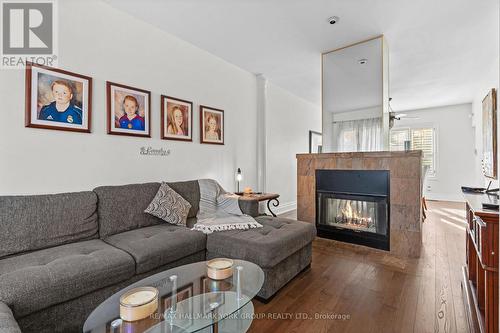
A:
[249,201,467,333]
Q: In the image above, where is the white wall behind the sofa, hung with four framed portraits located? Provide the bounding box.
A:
[0,0,258,194]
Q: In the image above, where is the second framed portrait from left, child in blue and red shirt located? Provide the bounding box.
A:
[106,81,151,138]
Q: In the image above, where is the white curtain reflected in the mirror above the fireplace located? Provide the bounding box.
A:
[333,117,382,152]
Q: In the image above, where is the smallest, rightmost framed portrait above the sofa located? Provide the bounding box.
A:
[200,105,224,145]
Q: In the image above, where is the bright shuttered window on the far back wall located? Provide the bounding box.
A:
[390,128,436,176]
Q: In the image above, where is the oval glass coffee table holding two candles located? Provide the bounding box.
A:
[83,260,264,333]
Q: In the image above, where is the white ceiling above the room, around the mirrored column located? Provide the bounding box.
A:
[105,0,499,111]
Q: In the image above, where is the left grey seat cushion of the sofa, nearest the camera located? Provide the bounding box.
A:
[0,239,135,317]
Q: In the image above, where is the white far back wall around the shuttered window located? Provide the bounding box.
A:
[394,104,474,201]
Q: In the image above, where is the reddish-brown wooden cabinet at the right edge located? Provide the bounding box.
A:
[462,193,499,333]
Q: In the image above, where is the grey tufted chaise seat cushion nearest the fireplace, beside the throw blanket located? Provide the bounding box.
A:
[207,216,316,268]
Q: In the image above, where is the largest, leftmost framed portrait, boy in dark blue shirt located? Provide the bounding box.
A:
[25,63,92,133]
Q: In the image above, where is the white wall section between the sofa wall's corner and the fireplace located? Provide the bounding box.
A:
[266,83,321,212]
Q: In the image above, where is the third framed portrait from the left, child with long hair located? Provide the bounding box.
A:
[161,95,193,141]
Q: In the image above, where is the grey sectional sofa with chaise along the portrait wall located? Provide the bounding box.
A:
[0,181,316,333]
